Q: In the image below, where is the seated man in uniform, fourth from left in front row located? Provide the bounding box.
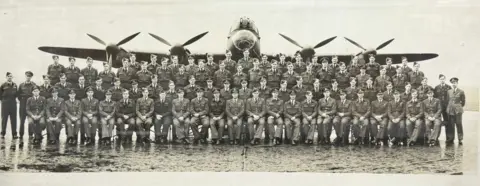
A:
[80,87,99,145]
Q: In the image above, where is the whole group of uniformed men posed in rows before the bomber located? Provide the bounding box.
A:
[0,51,465,145]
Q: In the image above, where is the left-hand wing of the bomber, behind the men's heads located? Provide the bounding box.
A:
[38,46,168,62]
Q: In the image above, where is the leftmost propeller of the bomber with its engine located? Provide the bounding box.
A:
[87,32,140,68]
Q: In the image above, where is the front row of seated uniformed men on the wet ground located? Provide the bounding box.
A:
[26,77,463,145]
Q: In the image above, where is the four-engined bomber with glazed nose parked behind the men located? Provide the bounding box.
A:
[38,17,438,68]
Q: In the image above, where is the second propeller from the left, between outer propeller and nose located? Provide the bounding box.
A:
[149,32,208,64]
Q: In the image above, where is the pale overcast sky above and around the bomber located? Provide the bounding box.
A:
[0,0,480,87]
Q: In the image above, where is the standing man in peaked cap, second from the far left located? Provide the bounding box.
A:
[14,71,37,139]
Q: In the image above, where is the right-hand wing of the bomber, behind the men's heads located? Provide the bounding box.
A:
[318,53,438,65]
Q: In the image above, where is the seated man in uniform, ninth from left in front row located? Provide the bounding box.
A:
[171,89,190,144]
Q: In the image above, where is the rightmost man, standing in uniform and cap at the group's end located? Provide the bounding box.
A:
[445,77,465,145]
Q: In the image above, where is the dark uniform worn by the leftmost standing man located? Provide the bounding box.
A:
[0,79,18,137]
